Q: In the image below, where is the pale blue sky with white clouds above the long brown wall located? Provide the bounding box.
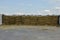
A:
[0,0,60,15]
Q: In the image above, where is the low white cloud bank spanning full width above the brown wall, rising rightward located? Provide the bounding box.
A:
[0,7,60,15]
